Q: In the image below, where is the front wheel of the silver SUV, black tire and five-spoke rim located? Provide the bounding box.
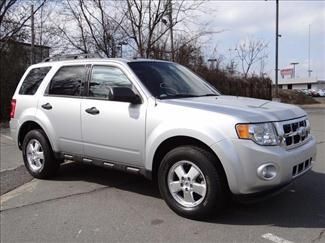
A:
[158,146,228,219]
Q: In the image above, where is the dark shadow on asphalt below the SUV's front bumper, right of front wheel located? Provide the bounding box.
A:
[213,171,325,228]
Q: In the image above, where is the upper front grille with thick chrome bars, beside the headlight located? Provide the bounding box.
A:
[283,118,309,146]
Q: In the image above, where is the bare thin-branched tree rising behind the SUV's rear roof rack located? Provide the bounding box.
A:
[57,0,126,57]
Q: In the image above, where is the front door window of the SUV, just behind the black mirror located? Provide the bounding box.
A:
[89,66,132,99]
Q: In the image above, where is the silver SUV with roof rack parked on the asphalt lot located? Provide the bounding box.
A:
[10,58,316,218]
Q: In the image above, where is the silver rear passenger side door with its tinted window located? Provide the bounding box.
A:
[38,65,87,155]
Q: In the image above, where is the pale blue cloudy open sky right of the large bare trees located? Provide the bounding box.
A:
[196,0,325,80]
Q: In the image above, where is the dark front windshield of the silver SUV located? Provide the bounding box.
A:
[128,61,219,99]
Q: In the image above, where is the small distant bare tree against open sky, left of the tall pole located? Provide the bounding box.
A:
[235,39,268,78]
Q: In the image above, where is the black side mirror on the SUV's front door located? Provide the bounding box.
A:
[109,87,142,105]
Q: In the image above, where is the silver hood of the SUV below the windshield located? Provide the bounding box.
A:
[161,95,306,122]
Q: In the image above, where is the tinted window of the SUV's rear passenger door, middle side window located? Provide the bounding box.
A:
[48,66,86,96]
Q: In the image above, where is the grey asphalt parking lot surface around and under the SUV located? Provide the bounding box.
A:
[0,108,325,243]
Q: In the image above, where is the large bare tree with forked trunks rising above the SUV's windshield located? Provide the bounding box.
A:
[122,0,203,57]
